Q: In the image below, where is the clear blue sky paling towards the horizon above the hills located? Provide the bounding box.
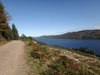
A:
[0,0,100,36]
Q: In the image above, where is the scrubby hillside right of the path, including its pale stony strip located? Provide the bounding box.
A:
[24,41,100,75]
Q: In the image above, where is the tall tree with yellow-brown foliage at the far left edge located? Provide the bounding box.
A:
[0,2,12,40]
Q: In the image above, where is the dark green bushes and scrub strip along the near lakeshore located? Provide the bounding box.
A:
[49,45,100,59]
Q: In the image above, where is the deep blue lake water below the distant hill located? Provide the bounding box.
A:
[35,38,100,54]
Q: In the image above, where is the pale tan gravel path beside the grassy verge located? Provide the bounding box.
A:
[0,41,27,75]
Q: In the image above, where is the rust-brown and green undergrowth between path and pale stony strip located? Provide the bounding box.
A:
[24,37,100,75]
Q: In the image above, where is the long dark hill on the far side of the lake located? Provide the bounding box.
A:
[41,30,100,39]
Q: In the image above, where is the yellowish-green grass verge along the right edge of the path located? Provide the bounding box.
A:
[24,41,49,75]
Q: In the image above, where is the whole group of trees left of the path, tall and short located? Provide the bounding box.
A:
[0,2,19,40]
